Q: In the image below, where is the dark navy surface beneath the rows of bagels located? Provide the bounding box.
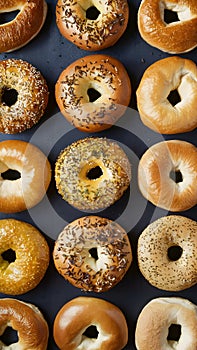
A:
[0,0,197,350]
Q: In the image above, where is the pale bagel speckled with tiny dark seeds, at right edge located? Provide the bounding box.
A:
[138,215,197,291]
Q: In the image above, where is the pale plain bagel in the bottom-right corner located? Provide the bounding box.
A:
[135,297,197,350]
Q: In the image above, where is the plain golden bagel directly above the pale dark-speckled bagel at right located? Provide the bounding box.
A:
[138,140,197,212]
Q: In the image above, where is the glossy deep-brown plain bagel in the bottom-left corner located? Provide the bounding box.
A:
[0,298,49,350]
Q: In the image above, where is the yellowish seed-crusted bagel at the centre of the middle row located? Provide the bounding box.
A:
[55,137,131,210]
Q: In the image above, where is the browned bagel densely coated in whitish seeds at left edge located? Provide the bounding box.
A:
[0,59,48,134]
